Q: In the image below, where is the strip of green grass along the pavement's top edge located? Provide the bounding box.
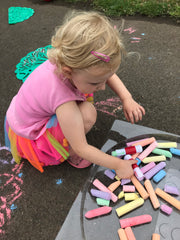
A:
[62,0,180,18]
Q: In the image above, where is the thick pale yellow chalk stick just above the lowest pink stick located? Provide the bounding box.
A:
[116,198,144,217]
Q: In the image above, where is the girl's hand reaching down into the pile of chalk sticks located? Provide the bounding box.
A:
[116,159,138,179]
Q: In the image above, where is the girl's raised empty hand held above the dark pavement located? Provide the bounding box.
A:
[122,98,145,124]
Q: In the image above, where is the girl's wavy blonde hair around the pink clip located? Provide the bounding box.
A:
[48,12,125,72]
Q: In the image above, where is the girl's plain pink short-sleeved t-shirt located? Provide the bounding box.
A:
[6,60,85,140]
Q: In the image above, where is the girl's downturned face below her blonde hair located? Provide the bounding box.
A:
[71,66,115,93]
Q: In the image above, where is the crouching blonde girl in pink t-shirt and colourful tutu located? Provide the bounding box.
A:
[5,12,145,178]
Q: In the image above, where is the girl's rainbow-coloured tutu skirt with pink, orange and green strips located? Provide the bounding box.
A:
[4,94,93,172]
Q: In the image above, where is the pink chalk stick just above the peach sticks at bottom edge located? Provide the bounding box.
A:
[119,214,152,228]
